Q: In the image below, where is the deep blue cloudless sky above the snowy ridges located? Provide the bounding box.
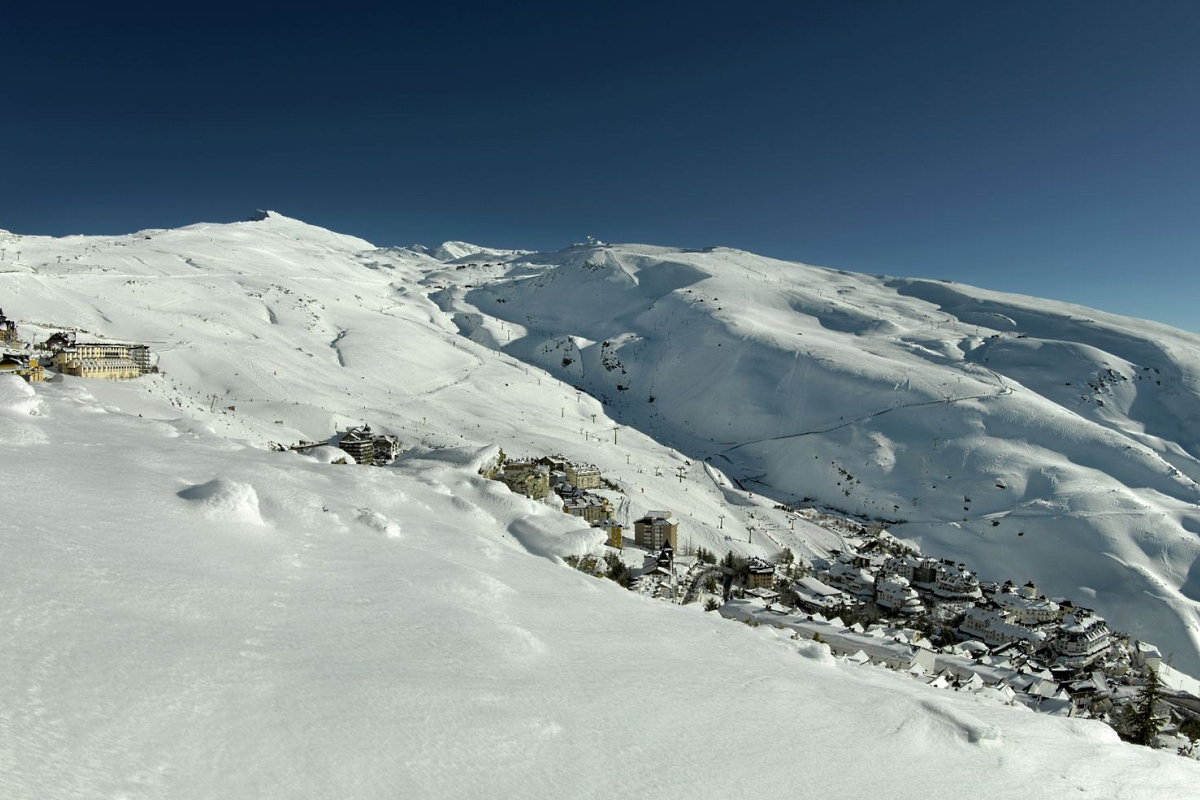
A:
[0,0,1200,331]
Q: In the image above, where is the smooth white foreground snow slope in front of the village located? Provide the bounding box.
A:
[0,378,1200,800]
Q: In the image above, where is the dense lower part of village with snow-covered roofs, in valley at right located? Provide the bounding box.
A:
[705,527,1200,734]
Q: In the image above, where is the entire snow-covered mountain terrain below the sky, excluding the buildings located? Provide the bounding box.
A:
[0,213,1200,798]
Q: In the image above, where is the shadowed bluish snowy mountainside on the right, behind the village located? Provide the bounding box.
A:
[437,245,1200,672]
